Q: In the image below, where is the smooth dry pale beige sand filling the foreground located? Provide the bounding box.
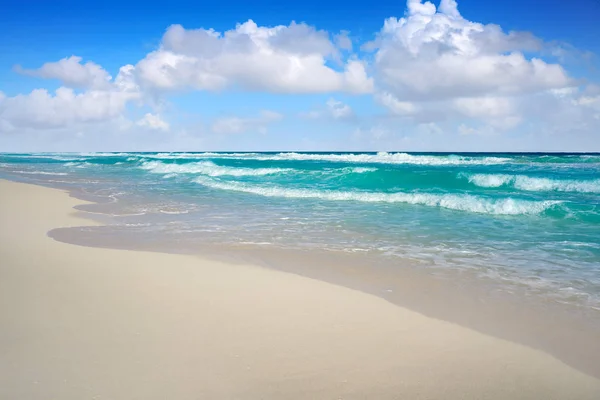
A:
[0,181,600,400]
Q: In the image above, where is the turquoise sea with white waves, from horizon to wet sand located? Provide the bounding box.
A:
[0,153,600,308]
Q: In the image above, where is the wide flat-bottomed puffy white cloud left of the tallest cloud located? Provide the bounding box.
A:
[136,20,373,93]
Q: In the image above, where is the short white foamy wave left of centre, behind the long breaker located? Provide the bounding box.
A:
[140,161,292,176]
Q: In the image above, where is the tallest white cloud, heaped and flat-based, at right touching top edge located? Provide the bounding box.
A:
[371,0,571,101]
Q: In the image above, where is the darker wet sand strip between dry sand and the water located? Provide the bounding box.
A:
[48,182,600,379]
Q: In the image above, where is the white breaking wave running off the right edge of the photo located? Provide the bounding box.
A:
[462,174,600,193]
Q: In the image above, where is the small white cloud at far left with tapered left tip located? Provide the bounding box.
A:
[15,56,111,89]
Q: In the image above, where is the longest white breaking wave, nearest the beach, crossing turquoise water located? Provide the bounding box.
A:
[194,177,561,215]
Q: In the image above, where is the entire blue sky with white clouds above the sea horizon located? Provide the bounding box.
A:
[0,0,600,152]
